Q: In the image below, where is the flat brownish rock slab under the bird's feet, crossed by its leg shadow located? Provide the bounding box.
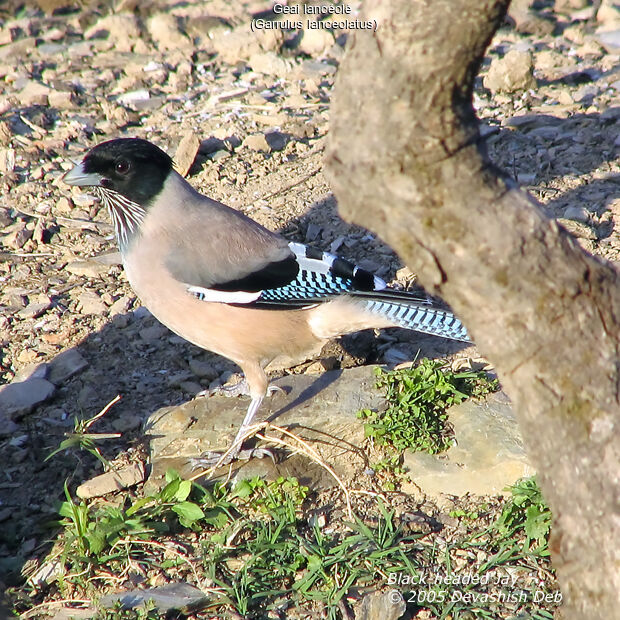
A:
[146,366,386,488]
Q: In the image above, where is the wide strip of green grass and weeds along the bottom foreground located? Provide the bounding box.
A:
[14,472,553,620]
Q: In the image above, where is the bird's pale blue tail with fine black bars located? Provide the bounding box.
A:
[349,289,471,342]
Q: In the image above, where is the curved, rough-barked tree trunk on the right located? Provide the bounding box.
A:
[326,0,620,619]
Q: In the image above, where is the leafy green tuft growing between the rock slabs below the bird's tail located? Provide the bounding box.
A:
[358,359,498,454]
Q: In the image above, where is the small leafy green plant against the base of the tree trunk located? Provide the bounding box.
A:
[495,476,552,556]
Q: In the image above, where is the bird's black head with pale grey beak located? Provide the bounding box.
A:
[64,138,172,207]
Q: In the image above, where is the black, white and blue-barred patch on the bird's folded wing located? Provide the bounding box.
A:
[188,242,386,308]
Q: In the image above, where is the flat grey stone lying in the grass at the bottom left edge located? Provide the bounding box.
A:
[99,583,208,615]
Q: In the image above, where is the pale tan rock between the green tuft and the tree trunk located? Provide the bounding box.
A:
[403,392,535,497]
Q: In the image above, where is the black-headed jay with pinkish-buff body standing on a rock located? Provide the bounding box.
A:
[63,138,470,462]
